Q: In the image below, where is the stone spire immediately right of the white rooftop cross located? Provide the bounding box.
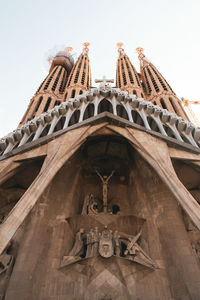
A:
[116,43,144,98]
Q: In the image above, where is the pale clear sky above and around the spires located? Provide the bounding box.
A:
[0,0,200,137]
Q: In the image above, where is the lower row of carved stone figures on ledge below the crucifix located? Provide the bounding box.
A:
[61,226,156,269]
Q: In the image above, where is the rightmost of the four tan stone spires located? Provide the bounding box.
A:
[136,47,188,120]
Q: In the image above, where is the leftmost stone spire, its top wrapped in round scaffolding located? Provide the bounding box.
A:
[19,47,74,127]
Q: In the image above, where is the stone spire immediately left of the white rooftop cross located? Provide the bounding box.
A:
[65,43,91,100]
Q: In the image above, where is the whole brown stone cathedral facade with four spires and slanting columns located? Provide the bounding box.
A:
[0,43,200,300]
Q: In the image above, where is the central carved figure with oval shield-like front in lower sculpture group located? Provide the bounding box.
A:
[99,226,114,258]
